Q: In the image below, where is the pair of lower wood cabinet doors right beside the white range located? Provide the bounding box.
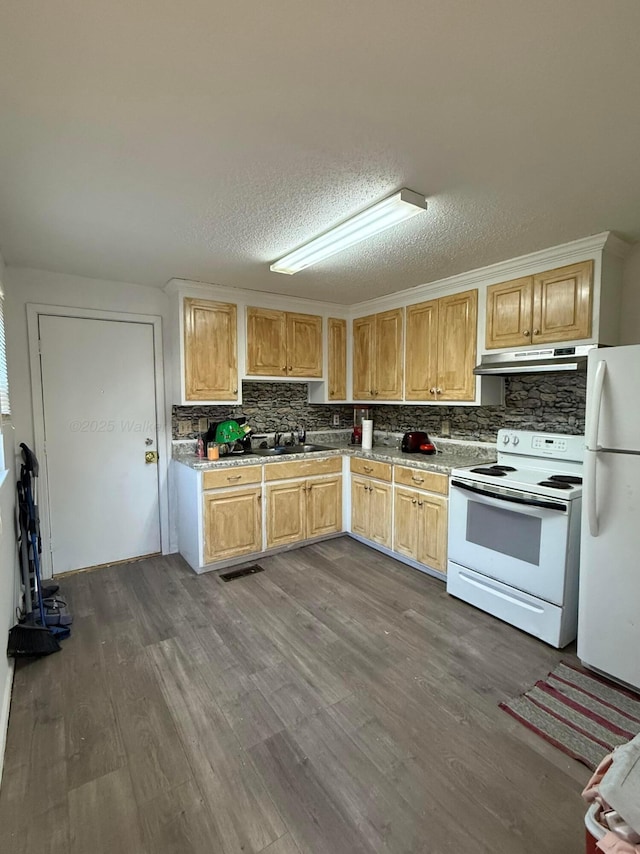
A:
[393,486,447,572]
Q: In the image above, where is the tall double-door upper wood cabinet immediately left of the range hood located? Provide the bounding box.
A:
[405,290,478,401]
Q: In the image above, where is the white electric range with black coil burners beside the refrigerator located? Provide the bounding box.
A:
[447,430,585,648]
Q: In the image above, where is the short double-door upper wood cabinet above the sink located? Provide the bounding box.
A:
[246,306,322,378]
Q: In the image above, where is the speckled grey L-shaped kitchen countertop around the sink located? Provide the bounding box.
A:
[173,433,497,474]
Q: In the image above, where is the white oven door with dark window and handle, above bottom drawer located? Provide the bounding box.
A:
[449,477,570,605]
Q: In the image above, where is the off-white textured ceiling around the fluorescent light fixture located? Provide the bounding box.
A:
[0,0,640,303]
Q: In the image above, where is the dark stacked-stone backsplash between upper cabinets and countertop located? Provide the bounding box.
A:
[172,373,586,442]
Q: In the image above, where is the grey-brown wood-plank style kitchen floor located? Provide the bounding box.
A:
[0,538,588,854]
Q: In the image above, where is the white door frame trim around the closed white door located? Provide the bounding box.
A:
[27,303,171,578]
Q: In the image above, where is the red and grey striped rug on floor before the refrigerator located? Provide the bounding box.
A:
[500,662,640,770]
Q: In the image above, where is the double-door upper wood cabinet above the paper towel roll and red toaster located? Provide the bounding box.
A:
[353,308,403,400]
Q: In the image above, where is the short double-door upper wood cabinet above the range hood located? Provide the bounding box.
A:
[486,261,593,350]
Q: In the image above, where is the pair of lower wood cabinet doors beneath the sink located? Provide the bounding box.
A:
[267,475,342,548]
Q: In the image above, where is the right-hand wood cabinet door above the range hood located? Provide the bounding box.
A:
[532,261,593,344]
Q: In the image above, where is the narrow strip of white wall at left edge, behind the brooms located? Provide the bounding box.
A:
[0,256,19,779]
